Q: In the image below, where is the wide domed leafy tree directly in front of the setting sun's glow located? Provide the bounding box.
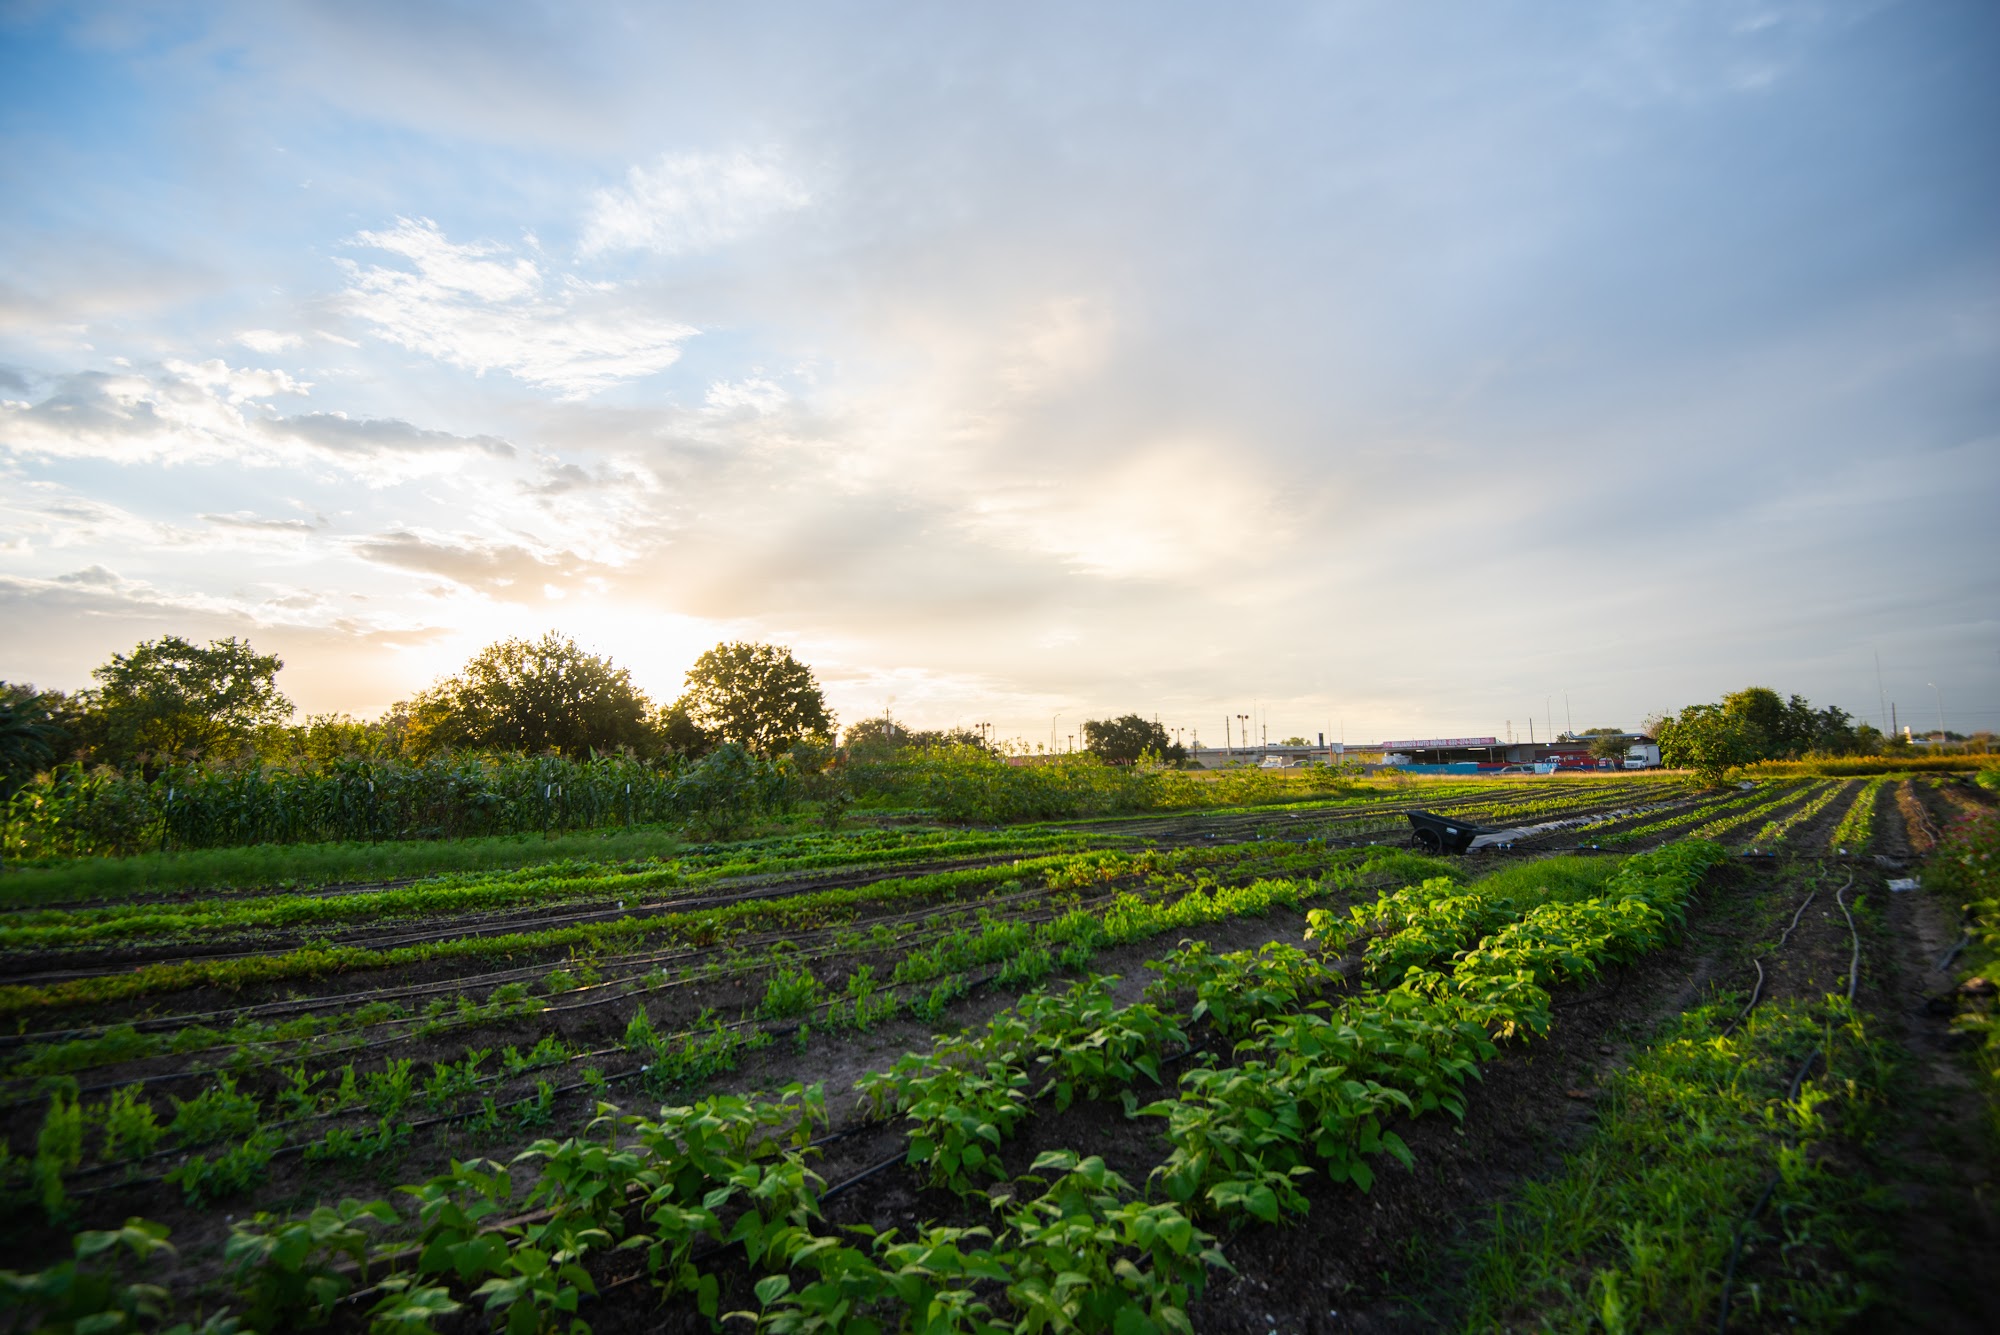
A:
[404,632,652,759]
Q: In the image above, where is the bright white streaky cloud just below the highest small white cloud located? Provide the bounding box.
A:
[342,218,698,398]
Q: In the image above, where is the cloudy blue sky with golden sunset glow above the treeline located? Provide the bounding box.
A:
[0,0,2000,745]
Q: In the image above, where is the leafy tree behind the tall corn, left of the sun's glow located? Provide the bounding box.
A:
[82,636,292,763]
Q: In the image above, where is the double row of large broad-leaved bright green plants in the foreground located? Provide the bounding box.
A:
[8,843,1724,1335]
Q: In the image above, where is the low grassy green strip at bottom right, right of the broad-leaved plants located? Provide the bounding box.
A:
[1464,995,1892,1331]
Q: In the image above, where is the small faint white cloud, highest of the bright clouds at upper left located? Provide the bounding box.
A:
[582,152,812,256]
